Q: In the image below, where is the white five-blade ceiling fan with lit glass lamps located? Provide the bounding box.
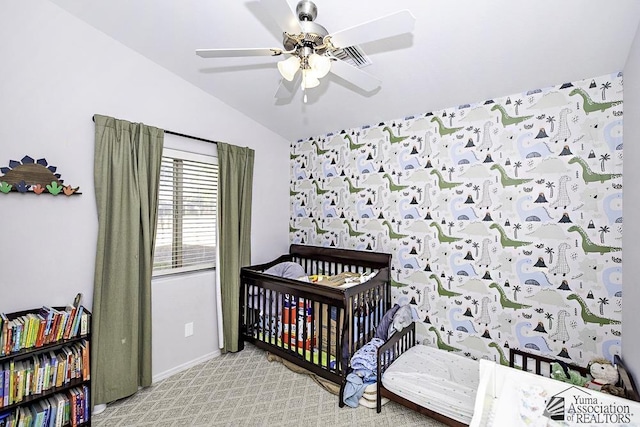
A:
[196,0,415,102]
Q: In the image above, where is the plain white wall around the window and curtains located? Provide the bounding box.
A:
[0,0,289,377]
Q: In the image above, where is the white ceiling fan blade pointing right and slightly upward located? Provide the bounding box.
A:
[329,10,416,48]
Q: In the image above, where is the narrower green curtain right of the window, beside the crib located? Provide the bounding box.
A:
[217,142,254,353]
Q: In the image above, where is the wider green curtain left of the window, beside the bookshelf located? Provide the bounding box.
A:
[91,115,164,405]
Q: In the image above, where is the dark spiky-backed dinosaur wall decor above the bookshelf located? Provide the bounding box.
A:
[0,156,82,196]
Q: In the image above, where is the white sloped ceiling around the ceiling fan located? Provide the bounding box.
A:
[51,0,640,140]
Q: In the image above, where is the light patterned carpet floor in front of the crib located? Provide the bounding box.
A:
[92,344,443,427]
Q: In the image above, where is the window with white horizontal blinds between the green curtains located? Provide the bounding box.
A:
[153,148,218,276]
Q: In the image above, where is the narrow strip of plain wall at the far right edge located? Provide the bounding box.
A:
[622,24,640,381]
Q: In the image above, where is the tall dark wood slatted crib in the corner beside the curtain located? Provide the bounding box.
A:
[239,244,391,385]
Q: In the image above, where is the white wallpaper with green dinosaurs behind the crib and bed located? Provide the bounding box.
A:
[290,73,623,365]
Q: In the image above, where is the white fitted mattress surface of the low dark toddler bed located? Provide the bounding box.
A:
[382,345,479,424]
